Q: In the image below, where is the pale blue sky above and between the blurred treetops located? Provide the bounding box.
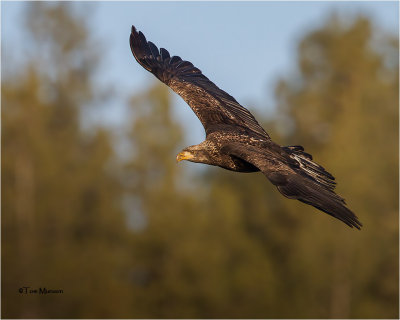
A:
[2,1,399,144]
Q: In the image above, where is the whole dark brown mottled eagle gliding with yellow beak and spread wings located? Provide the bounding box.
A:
[129,26,362,229]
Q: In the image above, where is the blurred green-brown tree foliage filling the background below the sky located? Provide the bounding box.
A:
[1,3,399,318]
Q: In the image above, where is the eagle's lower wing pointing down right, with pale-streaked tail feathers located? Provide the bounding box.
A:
[222,142,362,229]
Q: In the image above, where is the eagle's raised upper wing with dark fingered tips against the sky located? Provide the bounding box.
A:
[129,26,269,139]
